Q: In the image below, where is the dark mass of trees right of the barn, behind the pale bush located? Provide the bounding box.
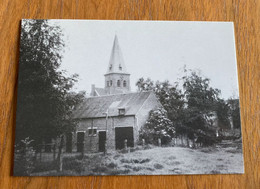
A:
[136,69,240,144]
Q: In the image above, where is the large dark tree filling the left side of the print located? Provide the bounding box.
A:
[16,20,84,147]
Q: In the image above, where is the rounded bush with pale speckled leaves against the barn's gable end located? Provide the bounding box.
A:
[140,108,175,144]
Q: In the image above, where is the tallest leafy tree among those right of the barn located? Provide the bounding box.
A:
[182,71,220,139]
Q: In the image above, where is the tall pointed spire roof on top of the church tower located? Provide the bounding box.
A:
[106,35,129,74]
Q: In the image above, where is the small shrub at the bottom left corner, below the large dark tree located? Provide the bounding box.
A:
[14,137,35,176]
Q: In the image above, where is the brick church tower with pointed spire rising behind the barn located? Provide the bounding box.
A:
[105,35,130,94]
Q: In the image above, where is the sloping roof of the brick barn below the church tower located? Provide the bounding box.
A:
[74,92,154,119]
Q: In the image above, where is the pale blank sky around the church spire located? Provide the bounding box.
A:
[51,20,239,99]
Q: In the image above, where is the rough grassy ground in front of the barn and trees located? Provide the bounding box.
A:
[31,139,244,175]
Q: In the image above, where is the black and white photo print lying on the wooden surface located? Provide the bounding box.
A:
[13,19,244,176]
